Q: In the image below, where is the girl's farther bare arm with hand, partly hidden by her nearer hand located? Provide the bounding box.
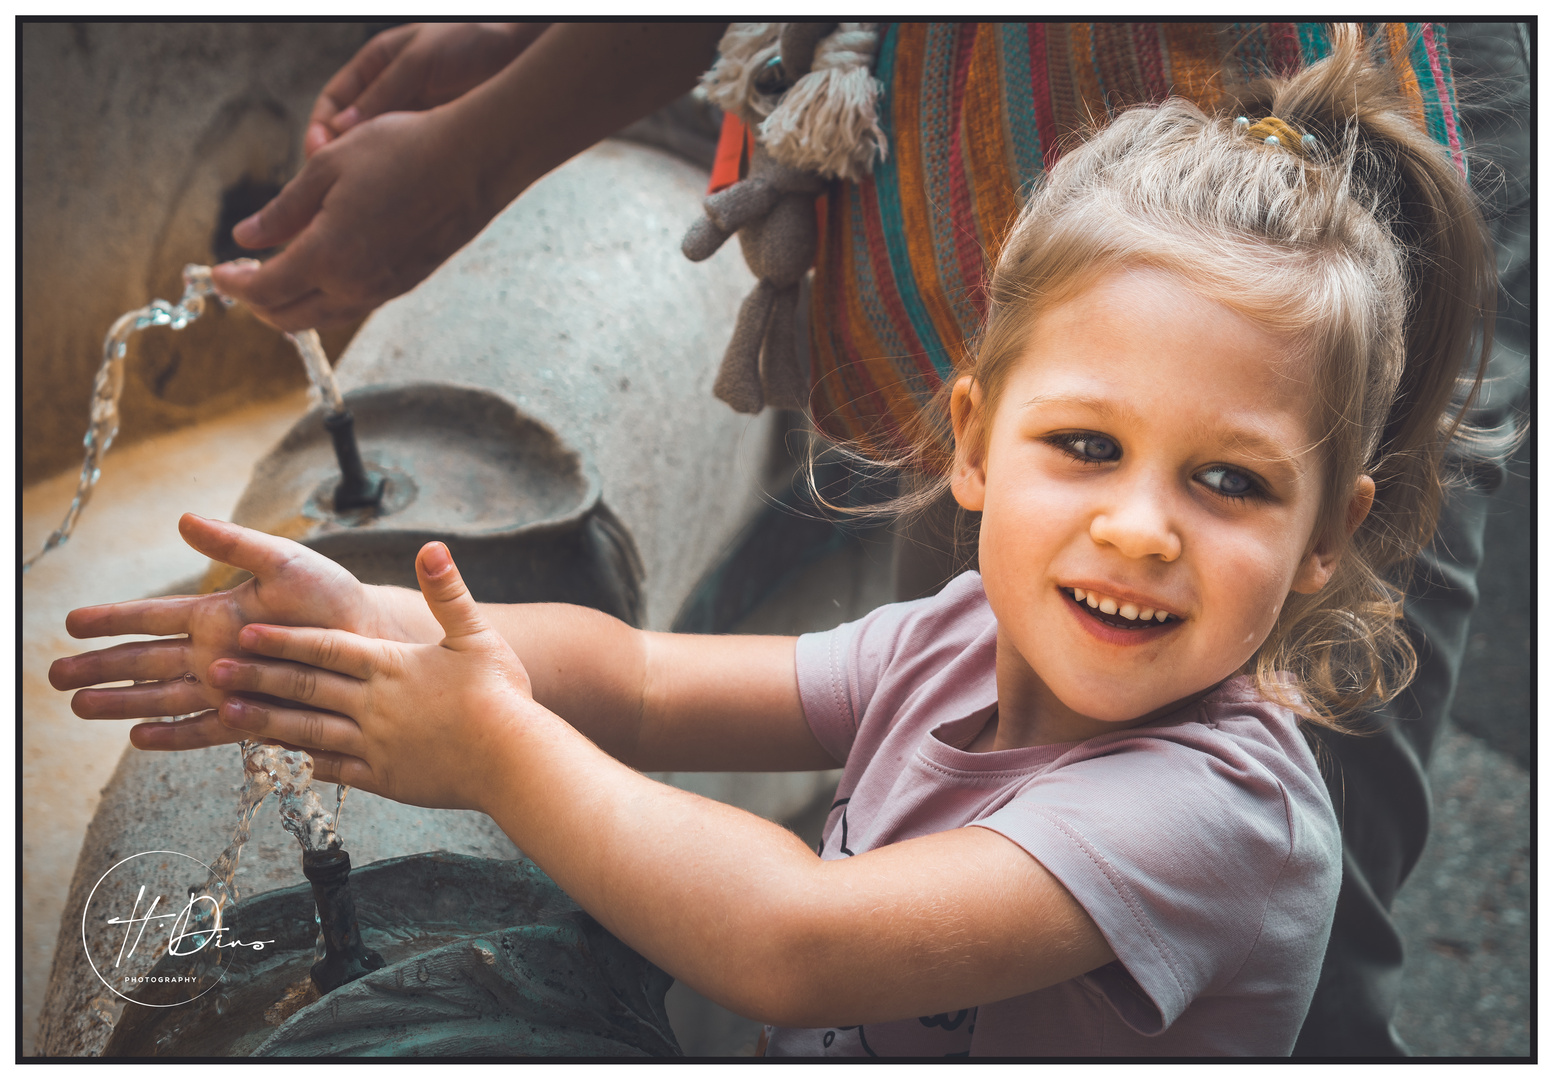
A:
[59,514,836,771]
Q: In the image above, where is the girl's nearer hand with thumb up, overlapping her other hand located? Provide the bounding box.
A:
[210,541,534,810]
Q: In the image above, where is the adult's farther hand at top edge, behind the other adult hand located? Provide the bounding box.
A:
[303,22,550,157]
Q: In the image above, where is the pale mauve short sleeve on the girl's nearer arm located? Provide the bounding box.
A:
[975,724,1340,1035]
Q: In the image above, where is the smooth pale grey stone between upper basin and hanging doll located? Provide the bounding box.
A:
[340,140,775,628]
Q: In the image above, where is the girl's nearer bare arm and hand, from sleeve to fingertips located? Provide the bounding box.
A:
[210,545,1114,1026]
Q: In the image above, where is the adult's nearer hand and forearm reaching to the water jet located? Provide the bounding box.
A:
[211,22,722,331]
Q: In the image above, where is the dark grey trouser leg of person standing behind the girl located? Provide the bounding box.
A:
[1294,23,1531,1057]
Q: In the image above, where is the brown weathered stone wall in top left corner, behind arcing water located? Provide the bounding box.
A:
[17,23,374,483]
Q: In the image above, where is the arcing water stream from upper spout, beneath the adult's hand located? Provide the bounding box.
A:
[22,263,345,573]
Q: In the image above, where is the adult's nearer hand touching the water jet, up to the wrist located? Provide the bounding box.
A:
[211,109,500,331]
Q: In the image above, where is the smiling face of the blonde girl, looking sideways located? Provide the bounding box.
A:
[952,270,1367,746]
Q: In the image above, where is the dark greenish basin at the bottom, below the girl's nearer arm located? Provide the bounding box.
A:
[104,852,679,1058]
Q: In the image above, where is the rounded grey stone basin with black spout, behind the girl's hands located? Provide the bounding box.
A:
[214,382,641,625]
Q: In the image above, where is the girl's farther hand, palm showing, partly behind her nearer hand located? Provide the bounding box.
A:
[48,514,431,751]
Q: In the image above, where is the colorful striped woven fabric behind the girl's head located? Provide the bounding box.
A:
[811,22,1464,454]
